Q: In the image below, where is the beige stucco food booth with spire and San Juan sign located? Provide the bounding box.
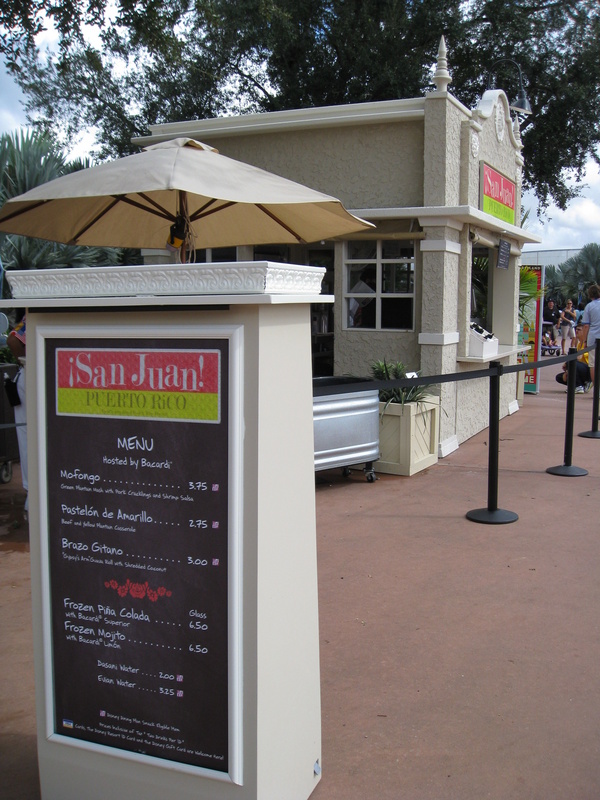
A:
[134,39,539,457]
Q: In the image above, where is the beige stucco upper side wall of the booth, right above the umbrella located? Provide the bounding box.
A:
[191,121,423,208]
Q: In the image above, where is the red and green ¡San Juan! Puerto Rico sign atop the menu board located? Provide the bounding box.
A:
[56,347,221,423]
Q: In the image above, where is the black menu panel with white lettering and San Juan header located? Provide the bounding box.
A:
[45,337,229,772]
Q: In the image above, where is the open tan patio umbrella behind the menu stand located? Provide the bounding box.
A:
[0,139,372,250]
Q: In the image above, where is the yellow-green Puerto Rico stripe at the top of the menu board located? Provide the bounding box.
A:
[56,389,219,422]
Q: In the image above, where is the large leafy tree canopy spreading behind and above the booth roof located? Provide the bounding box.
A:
[0,0,600,208]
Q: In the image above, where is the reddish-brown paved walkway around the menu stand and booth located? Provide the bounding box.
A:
[0,367,600,800]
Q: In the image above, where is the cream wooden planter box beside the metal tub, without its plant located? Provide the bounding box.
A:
[374,395,440,475]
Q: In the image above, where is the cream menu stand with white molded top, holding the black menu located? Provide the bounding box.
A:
[3,262,333,800]
